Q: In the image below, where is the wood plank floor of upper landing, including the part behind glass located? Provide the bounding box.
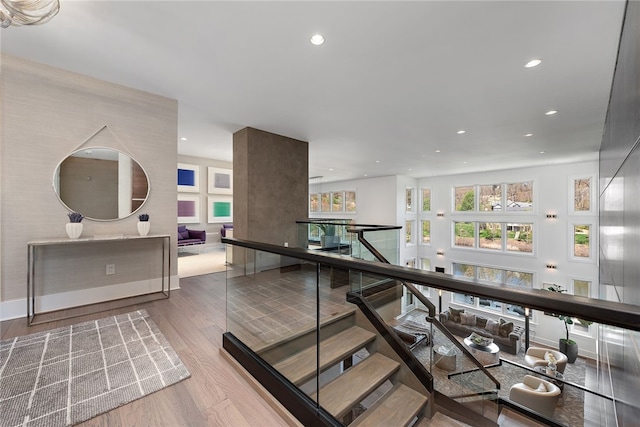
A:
[0,271,600,427]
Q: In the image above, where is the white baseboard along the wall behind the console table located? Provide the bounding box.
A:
[0,276,180,321]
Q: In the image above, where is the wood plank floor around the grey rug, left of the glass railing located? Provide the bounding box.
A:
[0,273,300,427]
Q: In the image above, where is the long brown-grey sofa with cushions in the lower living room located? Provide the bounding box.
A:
[439,307,524,354]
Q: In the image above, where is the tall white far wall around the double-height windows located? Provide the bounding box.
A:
[418,161,598,356]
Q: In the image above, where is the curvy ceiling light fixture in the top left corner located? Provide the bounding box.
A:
[0,0,60,28]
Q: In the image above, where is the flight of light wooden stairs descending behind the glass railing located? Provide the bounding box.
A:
[260,313,428,426]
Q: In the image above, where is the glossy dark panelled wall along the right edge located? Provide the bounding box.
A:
[599,1,640,426]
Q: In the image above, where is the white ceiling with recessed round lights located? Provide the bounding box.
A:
[0,0,625,181]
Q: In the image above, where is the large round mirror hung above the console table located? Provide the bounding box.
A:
[53,147,149,221]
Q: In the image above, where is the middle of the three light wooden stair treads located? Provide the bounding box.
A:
[311,353,400,419]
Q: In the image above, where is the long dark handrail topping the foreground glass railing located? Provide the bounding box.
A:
[222,238,640,331]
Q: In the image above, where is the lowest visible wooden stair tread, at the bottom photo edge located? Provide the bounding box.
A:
[349,384,428,427]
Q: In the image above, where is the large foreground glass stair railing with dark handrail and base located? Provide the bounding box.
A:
[222,239,640,426]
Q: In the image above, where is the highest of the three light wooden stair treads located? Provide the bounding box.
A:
[273,326,376,385]
